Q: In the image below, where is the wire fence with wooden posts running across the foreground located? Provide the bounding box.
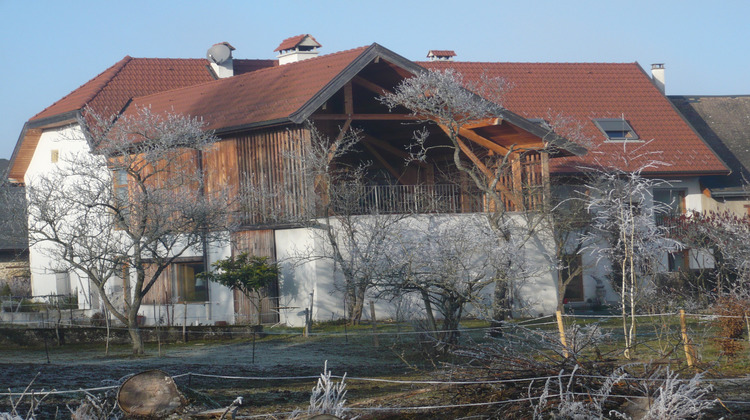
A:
[0,312,750,418]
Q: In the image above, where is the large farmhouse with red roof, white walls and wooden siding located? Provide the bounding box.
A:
[9,35,728,325]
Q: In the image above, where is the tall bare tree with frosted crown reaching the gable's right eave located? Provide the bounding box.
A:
[380,70,576,325]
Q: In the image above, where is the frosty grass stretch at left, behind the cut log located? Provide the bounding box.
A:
[0,331,446,413]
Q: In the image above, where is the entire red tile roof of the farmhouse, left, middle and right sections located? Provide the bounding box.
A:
[14,43,726,180]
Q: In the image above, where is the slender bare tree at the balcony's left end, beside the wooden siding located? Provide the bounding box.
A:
[288,124,409,324]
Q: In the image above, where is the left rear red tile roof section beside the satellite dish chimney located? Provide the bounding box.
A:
[30,56,214,122]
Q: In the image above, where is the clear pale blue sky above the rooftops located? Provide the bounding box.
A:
[0,0,750,158]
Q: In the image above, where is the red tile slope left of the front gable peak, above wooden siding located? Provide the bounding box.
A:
[126,47,368,130]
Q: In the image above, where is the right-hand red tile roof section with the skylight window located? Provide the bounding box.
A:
[418,61,727,174]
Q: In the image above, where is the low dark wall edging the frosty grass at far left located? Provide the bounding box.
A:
[0,325,264,346]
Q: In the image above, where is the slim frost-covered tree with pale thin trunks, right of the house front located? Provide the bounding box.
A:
[582,152,681,358]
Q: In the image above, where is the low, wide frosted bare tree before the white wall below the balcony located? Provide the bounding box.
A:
[378,215,523,344]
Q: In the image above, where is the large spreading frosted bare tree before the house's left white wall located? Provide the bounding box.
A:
[27,108,231,354]
